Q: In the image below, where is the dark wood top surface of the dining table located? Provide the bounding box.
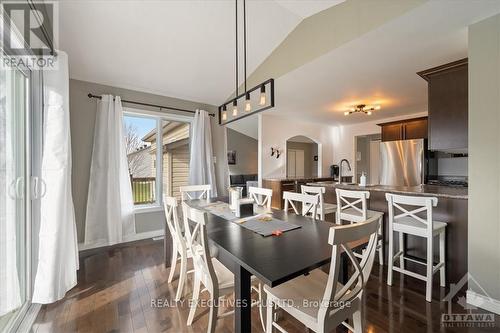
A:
[187,197,366,287]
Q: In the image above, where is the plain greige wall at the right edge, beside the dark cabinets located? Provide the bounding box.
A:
[467,15,500,308]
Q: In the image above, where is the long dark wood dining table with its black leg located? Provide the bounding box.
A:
[185,197,367,333]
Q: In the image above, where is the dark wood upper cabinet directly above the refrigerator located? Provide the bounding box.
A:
[378,117,427,141]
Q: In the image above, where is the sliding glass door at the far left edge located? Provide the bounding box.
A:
[0,61,31,331]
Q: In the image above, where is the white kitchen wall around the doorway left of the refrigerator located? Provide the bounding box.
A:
[332,112,427,176]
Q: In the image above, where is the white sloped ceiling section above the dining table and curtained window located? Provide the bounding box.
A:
[59,0,344,105]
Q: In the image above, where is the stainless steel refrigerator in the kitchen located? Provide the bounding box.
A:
[380,139,425,186]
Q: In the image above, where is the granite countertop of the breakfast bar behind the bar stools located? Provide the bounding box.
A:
[308,182,469,200]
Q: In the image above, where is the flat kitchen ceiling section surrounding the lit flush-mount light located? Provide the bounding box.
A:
[268,0,500,126]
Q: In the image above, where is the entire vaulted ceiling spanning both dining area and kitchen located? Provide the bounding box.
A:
[59,0,500,137]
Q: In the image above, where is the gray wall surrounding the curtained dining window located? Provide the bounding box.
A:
[69,79,228,242]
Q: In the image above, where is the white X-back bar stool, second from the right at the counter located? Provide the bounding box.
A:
[335,188,384,266]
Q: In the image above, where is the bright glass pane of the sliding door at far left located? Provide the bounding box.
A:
[0,58,21,316]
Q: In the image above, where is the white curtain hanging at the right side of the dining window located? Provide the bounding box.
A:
[189,110,217,197]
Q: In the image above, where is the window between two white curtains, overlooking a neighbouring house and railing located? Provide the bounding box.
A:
[124,111,190,207]
